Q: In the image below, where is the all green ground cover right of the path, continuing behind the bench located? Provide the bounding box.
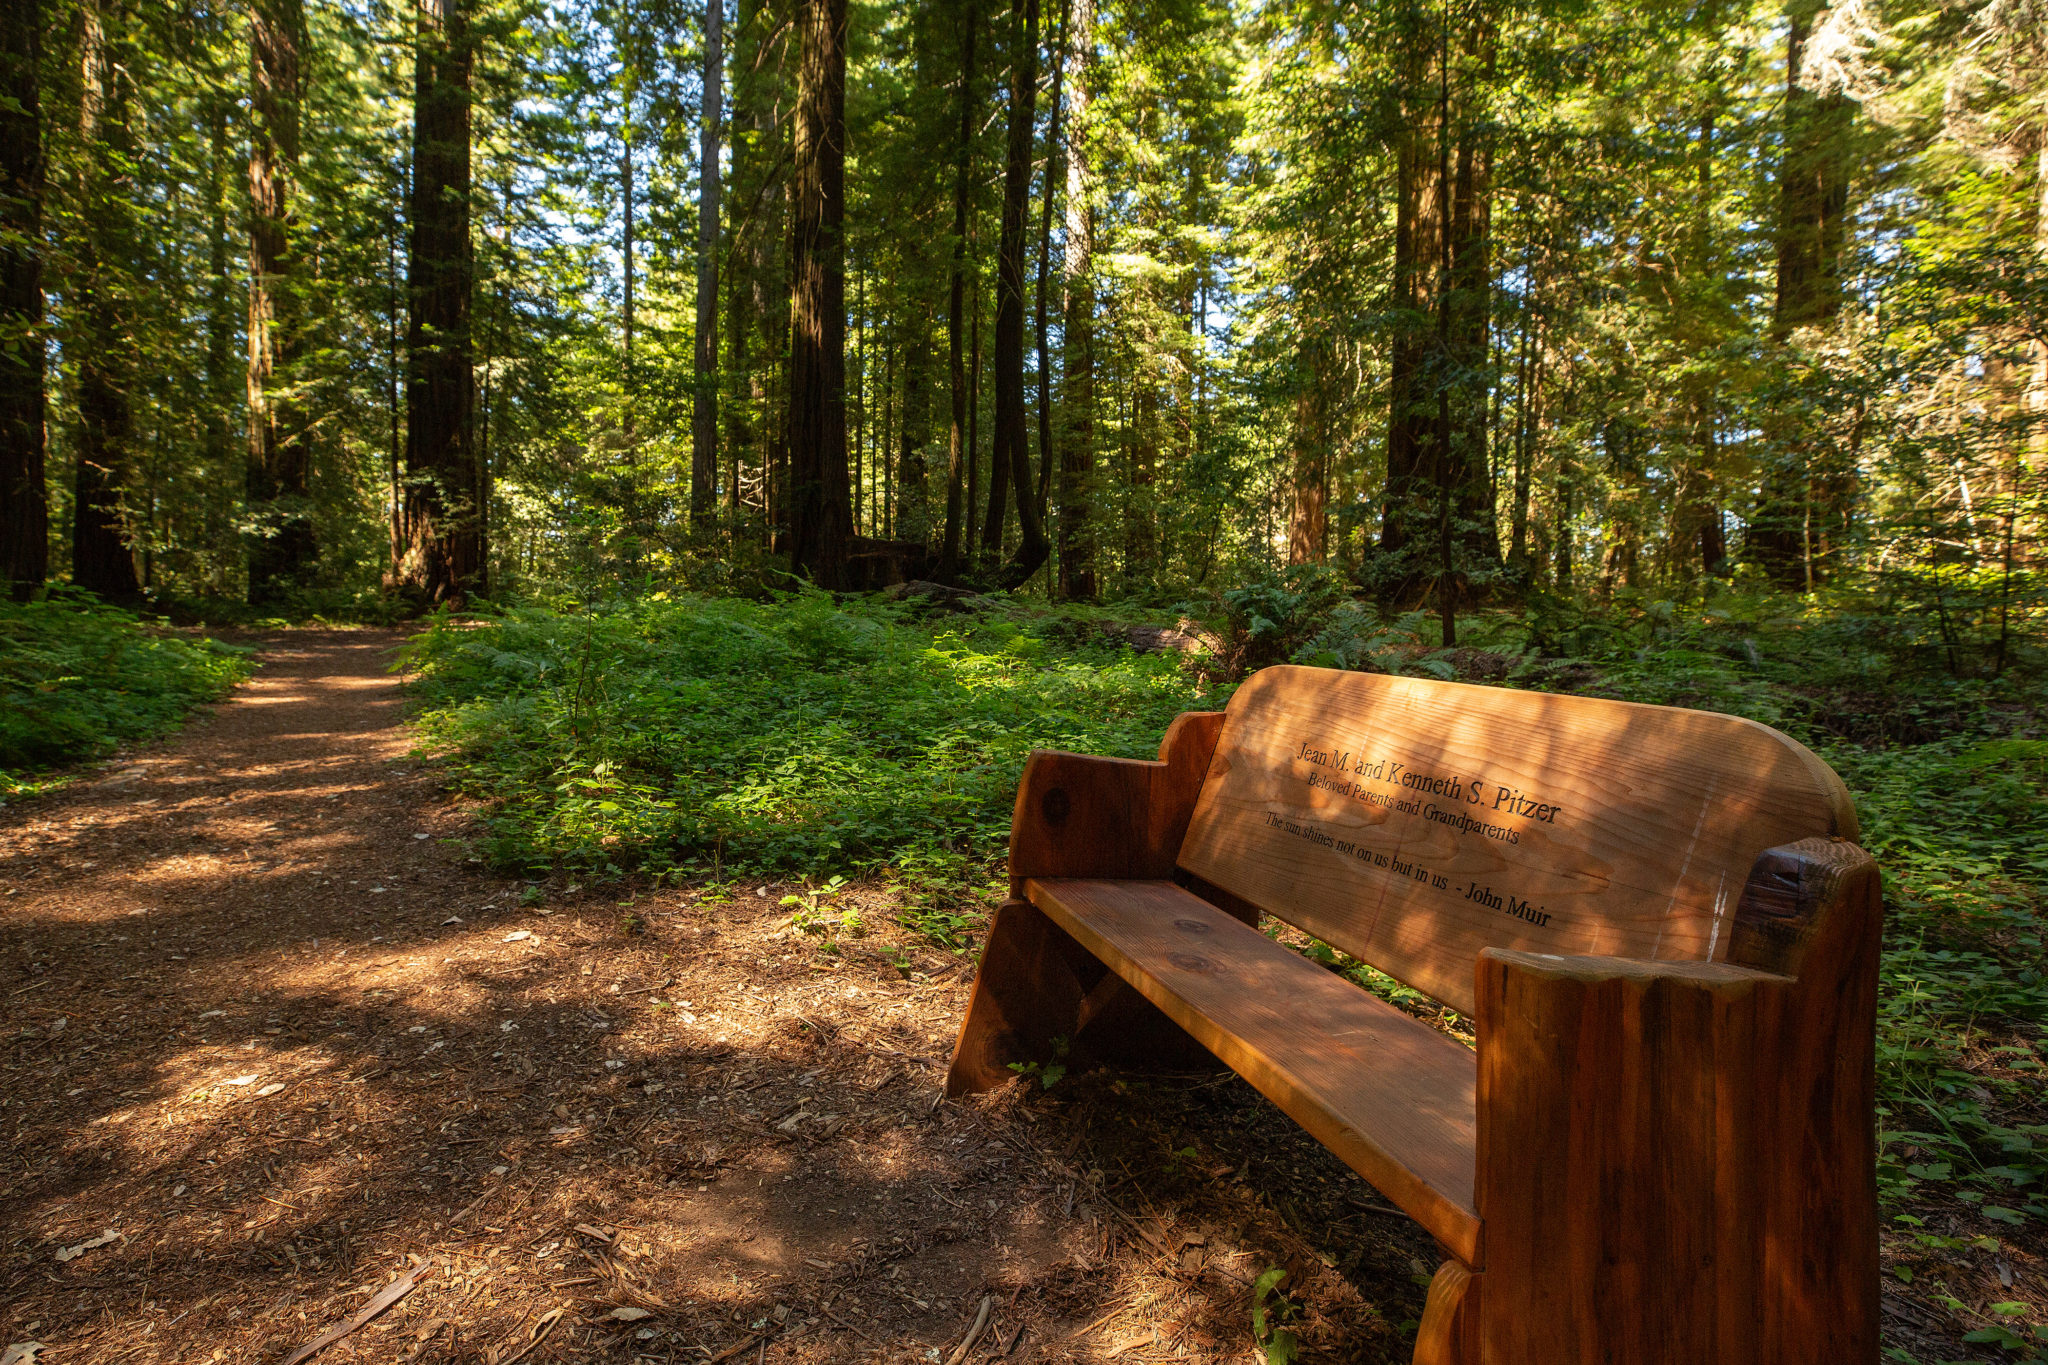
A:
[408,571,2048,1361]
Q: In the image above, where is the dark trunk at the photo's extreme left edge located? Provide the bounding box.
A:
[0,0,49,598]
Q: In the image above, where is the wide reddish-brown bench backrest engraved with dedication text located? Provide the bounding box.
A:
[1180,667,1858,1013]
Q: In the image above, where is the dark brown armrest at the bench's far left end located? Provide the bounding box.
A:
[1010,710,1223,896]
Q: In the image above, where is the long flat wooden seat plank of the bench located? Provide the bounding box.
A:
[1026,880,1481,1269]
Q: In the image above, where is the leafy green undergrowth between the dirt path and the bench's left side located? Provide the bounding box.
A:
[406,593,1229,939]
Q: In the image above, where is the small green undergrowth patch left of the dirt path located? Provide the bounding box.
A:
[0,593,250,796]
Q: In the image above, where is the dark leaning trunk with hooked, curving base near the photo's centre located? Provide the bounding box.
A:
[981,0,1053,587]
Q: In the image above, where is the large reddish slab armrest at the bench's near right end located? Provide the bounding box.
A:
[1475,839,1880,1365]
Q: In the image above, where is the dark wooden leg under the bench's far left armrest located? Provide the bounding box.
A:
[946,900,1102,1095]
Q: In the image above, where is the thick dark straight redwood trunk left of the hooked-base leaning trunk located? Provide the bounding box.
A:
[788,0,852,589]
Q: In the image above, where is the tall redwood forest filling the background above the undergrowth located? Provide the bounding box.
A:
[0,0,2048,634]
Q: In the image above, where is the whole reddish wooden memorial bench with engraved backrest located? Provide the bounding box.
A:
[946,667,1882,1365]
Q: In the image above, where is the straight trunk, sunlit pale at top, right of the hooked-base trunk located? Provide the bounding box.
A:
[1059,0,1096,602]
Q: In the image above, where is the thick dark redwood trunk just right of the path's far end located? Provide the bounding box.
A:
[393,0,477,604]
